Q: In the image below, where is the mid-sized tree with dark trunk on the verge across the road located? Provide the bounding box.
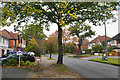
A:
[69,23,95,55]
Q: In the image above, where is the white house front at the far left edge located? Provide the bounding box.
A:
[0,34,14,57]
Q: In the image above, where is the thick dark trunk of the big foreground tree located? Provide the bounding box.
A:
[57,24,63,64]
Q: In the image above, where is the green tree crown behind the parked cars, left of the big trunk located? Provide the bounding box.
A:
[18,24,46,47]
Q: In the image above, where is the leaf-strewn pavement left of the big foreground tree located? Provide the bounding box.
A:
[26,56,80,78]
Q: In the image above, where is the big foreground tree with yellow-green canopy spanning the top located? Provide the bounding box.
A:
[2,2,116,64]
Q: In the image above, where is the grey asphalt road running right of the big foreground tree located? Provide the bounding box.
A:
[49,55,120,78]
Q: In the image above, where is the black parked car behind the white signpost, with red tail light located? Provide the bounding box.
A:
[1,54,35,64]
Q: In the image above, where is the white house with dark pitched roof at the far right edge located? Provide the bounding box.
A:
[108,33,120,48]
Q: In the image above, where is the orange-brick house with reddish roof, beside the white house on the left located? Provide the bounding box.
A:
[2,29,26,51]
